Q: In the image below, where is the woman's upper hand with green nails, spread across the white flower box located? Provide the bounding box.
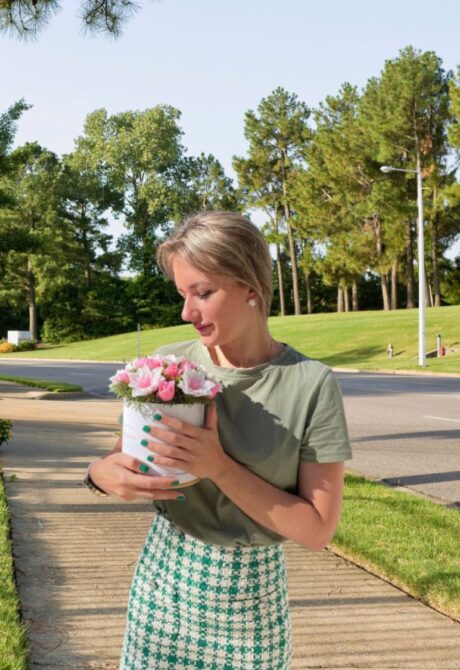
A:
[143,404,229,480]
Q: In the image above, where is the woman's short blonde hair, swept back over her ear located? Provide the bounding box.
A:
[156,211,273,317]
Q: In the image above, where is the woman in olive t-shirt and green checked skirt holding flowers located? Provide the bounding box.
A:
[90,212,351,670]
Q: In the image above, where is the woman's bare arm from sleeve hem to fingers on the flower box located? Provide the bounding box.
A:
[144,406,344,551]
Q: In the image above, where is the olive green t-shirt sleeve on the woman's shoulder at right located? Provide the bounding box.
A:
[300,370,351,463]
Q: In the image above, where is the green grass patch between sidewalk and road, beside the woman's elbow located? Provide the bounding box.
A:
[332,475,460,619]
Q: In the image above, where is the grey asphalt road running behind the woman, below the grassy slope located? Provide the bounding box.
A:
[0,360,460,508]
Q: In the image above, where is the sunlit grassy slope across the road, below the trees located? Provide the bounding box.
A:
[1,305,460,373]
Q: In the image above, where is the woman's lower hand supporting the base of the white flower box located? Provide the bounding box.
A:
[90,451,184,500]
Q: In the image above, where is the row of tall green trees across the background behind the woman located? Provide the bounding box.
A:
[0,47,460,342]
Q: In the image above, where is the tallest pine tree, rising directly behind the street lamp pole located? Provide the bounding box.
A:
[361,46,452,306]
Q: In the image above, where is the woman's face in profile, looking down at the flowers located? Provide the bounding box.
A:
[172,255,253,347]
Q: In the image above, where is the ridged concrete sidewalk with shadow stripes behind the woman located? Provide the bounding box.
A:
[0,382,460,670]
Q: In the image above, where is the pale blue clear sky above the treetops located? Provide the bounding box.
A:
[0,0,460,255]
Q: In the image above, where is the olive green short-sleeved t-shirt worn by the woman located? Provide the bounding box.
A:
[154,340,351,546]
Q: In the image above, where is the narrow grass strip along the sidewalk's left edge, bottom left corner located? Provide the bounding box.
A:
[0,471,28,670]
